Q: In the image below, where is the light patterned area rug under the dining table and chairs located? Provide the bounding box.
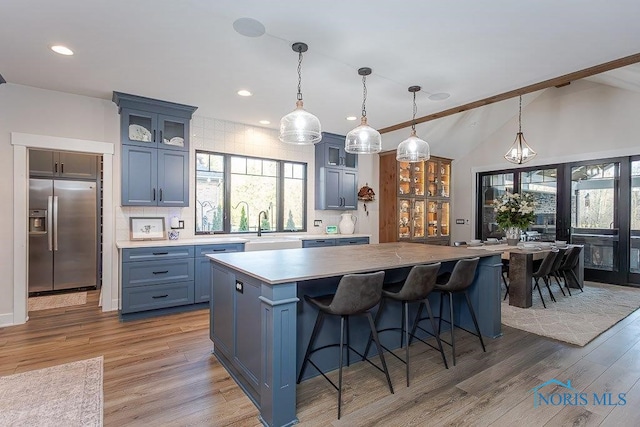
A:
[502,282,640,346]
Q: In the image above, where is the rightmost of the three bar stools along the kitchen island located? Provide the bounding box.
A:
[435,257,487,366]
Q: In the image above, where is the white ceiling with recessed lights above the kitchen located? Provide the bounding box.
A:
[0,0,640,154]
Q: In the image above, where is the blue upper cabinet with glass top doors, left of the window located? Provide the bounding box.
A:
[113,92,196,207]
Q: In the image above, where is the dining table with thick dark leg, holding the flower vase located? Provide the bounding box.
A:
[468,244,584,308]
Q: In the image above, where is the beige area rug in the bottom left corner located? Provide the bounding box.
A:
[0,356,103,427]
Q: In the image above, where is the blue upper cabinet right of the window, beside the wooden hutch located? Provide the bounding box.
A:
[315,133,358,211]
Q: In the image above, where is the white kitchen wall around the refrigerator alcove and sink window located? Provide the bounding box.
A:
[0,84,378,326]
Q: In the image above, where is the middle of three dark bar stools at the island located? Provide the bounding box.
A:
[364,263,449,387]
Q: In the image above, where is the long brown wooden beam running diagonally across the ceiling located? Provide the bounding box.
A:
[378,53,640,133]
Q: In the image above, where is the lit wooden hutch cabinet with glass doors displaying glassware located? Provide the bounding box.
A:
[379,151,451,245]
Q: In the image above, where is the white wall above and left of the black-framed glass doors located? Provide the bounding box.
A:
[451,81,640,241]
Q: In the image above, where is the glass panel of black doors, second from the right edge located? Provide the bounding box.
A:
[570,163,619,275]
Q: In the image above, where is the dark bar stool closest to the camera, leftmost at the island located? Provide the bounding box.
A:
[297,271,393,419]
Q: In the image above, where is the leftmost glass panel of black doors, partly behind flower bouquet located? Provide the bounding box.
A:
[479,173,513,240]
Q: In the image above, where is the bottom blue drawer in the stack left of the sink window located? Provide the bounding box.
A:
[121,281,194,314]
